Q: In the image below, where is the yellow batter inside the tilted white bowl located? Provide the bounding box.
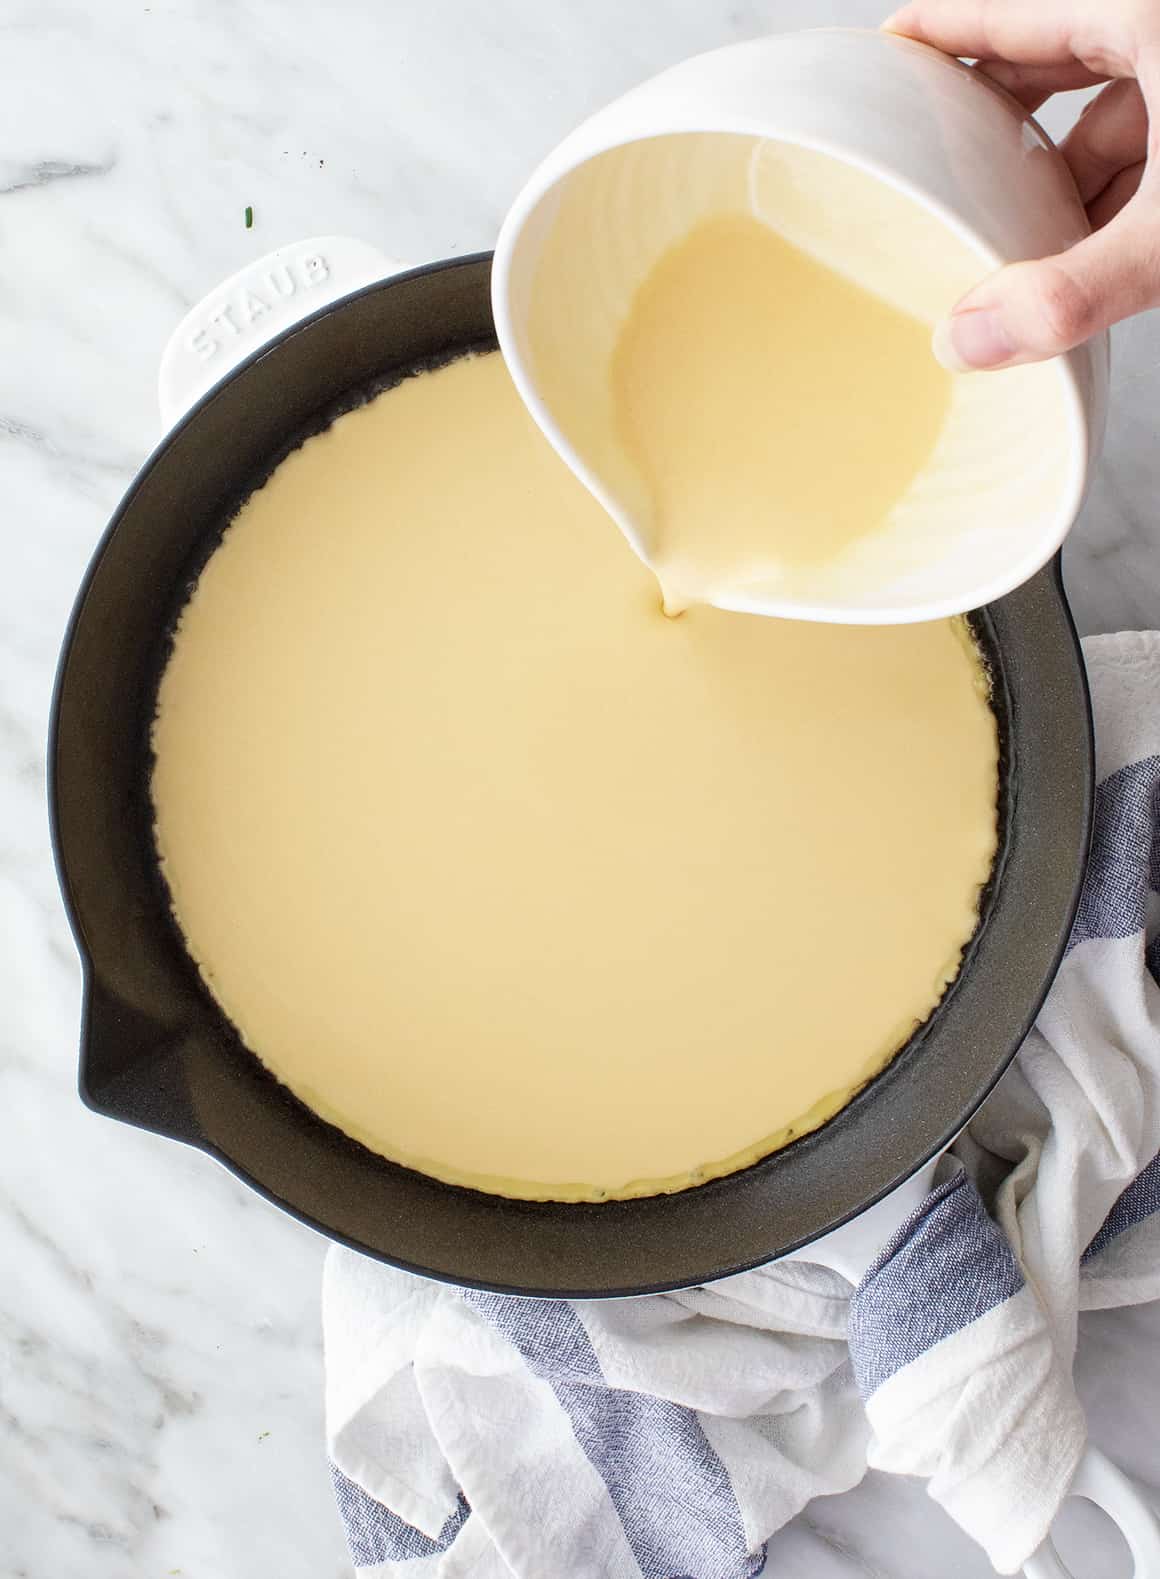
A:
[612,213,952,609]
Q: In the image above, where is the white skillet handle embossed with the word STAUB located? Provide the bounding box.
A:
[158,235,407,428]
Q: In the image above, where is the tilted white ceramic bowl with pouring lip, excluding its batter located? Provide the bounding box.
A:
[492,28,1108,624]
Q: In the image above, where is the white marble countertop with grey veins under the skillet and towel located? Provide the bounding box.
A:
[0,0,1160,1579]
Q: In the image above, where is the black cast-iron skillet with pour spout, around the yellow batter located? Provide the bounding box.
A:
[51,256,1092,1296]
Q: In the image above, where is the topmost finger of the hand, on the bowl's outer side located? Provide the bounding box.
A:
[882,0,1075,66]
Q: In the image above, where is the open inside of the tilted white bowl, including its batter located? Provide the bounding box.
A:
[520,133,1083,622]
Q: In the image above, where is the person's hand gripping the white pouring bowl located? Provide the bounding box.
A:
[884,0,1160,371]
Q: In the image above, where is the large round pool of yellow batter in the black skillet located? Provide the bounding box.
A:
[153,355,997,1200]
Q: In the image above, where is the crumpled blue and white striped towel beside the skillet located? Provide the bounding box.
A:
[324,633,1160,1579]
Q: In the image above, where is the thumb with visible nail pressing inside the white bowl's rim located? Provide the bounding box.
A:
[933,189,1160,373]
